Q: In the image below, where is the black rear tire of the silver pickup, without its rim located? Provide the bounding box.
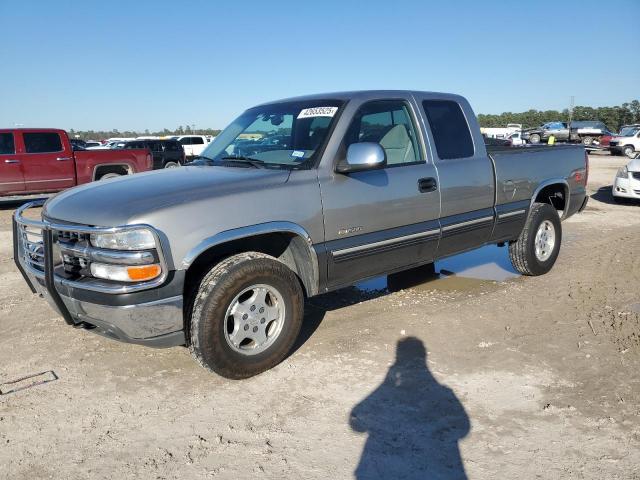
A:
[509,203,562,276]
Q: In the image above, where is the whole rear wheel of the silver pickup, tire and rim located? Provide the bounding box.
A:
[509,203,562,275]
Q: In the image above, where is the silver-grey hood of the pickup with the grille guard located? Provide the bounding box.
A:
[43,166,290,227]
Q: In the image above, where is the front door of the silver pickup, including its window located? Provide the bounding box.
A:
[320,100,440,288]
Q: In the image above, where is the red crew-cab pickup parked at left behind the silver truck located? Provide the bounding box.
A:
[0,128,153,196]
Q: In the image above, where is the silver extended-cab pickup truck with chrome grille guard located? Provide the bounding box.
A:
[14,91,588,378]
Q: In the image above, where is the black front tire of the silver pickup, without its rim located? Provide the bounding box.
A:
[189,252,304,379]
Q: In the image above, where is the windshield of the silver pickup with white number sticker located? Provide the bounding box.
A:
[193,100,344,168]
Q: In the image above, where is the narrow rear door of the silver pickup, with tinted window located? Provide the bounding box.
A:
[420,97,495,258]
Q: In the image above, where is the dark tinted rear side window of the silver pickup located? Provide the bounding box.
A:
[422,100,474,160]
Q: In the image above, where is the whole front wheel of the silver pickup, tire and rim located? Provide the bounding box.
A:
[189,252,304,379]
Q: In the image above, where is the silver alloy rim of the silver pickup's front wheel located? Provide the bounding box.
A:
[224,284,285,355]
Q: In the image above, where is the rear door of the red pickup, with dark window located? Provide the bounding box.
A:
[21,131,75,192]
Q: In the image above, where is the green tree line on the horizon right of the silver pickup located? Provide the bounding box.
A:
[478,100,640,132]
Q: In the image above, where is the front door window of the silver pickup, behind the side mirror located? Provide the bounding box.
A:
[344,100,422,166]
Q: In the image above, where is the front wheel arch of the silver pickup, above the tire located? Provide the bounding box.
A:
[182,222,319,296]
